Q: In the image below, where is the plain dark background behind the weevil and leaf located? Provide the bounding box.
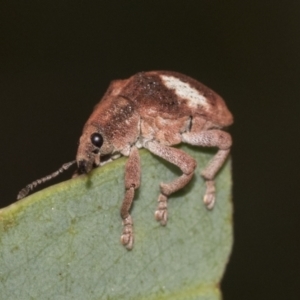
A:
[0,0,300,300]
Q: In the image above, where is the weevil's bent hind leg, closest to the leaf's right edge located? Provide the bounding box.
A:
[182,129,232,209]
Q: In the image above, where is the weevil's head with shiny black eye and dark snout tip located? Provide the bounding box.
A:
[76,124,113,174]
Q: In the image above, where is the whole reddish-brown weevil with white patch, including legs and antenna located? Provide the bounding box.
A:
[18,71,233,249]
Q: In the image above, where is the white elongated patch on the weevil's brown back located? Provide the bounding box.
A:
[160,75,209,108]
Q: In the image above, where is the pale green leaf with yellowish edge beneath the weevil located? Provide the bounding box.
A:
[0,146,232,300]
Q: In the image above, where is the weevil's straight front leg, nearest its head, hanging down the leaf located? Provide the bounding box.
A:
[121,147,141,250]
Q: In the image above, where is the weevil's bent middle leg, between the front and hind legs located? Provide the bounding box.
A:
[144,141,196,225]
